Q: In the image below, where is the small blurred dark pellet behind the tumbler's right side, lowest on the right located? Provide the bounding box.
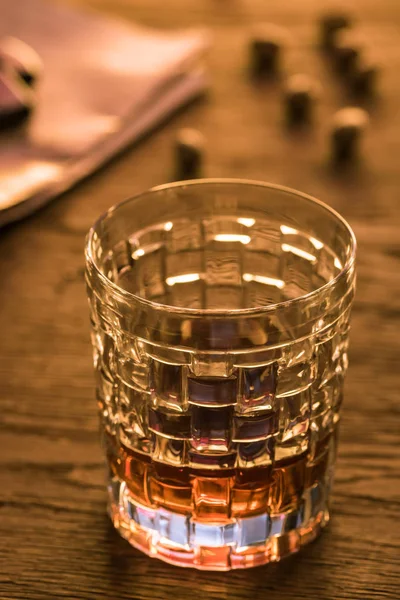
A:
[332,107,369,165]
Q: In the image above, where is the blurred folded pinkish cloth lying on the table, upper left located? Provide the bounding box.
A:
[0,0,208,225]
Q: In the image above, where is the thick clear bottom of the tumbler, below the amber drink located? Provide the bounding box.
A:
[109,479,329,571]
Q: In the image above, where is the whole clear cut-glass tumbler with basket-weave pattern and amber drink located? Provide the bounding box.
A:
[86,180,355,570]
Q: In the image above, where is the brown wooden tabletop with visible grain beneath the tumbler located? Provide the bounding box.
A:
[0,0,400,600]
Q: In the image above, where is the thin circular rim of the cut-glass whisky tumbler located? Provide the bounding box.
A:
[85,177,357,317]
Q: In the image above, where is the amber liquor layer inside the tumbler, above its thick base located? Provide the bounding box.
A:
[105,434,334,523]
